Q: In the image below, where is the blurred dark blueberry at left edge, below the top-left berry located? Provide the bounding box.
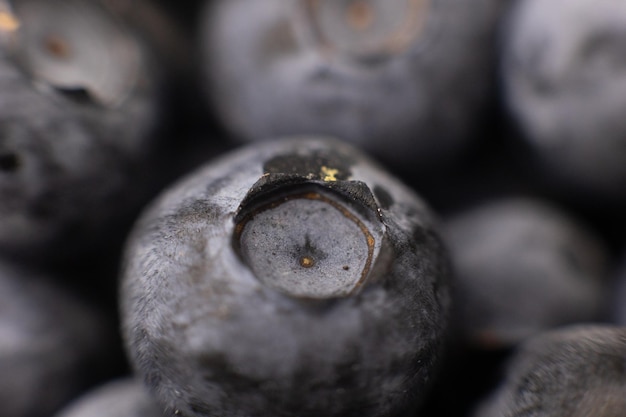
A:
[0,260,118,417]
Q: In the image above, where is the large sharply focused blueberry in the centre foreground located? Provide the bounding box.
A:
[120,138,449,417]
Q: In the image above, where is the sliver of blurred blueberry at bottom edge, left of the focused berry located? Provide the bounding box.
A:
[55,377,163,417]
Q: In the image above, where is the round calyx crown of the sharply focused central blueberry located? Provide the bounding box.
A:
[233,160,385,299]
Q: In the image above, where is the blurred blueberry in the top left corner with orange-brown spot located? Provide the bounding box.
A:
[0,0,177,258]
